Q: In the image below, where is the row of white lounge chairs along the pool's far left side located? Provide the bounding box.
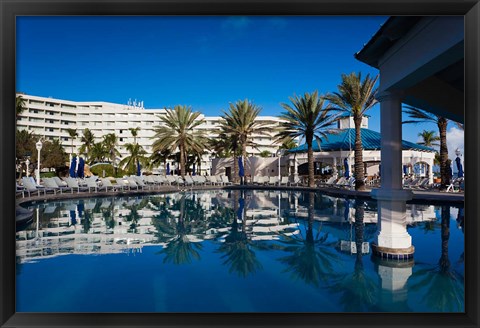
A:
[16,175,232,197]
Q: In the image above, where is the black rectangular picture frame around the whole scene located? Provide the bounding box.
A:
[0,0,480,327]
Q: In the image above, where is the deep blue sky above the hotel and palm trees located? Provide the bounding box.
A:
[16,16,463,149]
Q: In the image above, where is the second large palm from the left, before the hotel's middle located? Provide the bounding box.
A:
[220,99,267,183]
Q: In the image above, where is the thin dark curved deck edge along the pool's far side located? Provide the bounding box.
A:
[16,185,465,205]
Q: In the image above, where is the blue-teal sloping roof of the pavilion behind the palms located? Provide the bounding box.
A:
[288,128,435,153]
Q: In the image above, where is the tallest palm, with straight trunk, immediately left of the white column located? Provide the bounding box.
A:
[325,72,378,190]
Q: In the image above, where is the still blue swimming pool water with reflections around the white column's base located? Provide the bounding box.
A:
[16,190,464,312]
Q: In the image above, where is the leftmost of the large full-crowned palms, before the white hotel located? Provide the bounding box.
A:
[152,106,208,177]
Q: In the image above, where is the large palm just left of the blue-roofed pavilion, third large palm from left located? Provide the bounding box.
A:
[277,91,336,187]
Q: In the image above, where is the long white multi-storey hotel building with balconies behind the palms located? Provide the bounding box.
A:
[17,93,280,174]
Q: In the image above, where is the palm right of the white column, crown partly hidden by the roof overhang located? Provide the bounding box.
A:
[403,106,450,189]
